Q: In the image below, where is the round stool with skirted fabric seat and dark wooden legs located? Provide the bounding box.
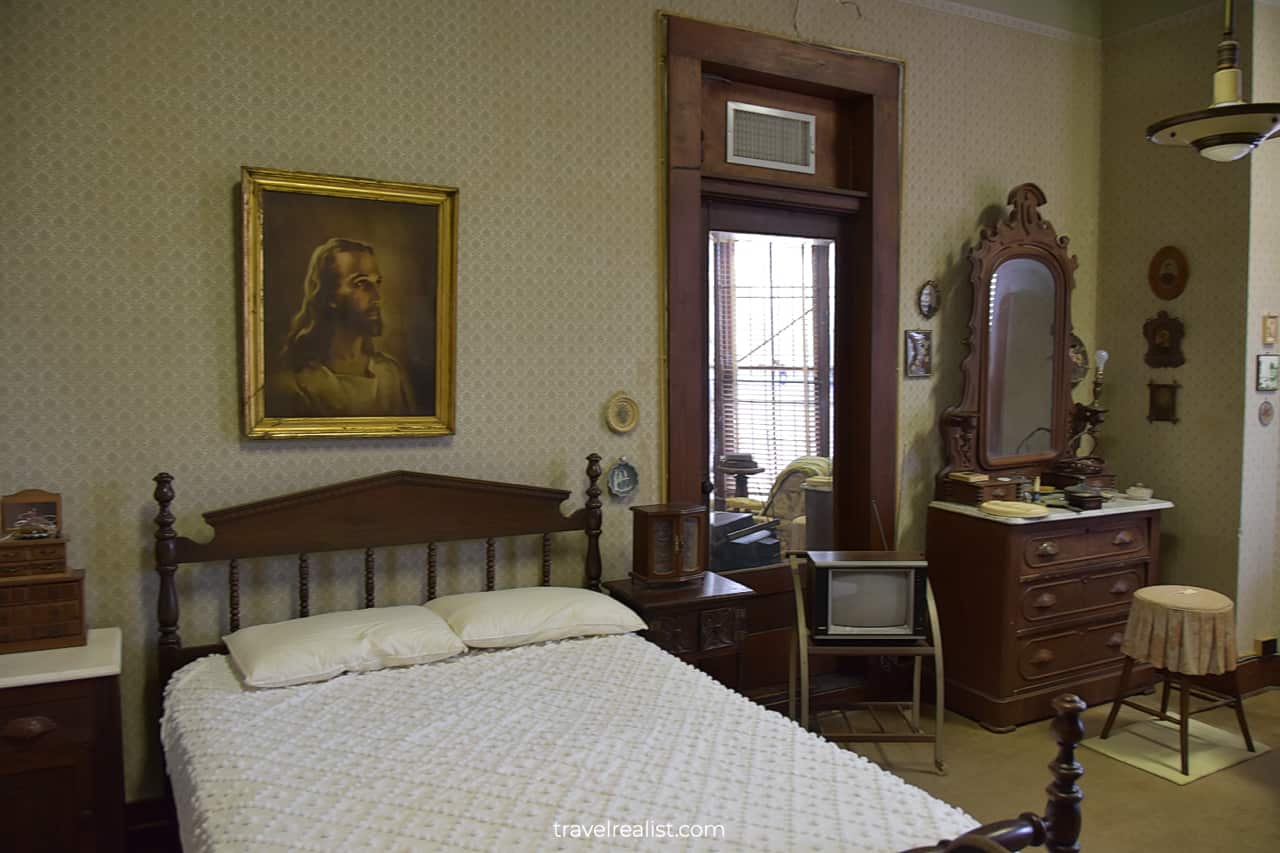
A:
[1102,585,1254,775]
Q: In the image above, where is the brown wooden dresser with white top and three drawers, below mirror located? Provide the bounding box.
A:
[927,498,1172,730]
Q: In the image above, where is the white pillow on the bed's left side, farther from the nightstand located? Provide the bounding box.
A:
[223,605,466,688]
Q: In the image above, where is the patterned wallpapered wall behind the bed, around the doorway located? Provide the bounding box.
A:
[0,0,1100,799]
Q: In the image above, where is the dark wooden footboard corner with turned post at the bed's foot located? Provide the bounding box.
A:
[905,693,1085,853]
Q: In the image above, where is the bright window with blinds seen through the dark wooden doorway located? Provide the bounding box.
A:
[708,231,836,501]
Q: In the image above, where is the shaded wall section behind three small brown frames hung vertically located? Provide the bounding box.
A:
[1098,4,1249,597]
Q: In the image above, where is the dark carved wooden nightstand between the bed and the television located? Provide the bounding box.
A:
[604,571,755,686]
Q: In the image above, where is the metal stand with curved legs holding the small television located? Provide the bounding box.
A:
[787,552,946,774]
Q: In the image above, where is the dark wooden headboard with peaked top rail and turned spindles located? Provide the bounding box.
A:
[154,453,602,684]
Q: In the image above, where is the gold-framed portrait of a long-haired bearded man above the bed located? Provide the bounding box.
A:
[241,167,458,438]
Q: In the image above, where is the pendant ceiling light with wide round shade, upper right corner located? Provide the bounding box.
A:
[1147,0,1280,163]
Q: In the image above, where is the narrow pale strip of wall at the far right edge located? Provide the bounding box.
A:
[1236,3,1280,653]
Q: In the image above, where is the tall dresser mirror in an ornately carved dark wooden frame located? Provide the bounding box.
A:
[940,183,1076,497]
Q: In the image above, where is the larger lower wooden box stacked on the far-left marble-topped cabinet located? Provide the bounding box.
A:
[0,571,84,653]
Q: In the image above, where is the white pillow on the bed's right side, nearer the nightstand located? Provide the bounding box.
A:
[425,587,648,648]
